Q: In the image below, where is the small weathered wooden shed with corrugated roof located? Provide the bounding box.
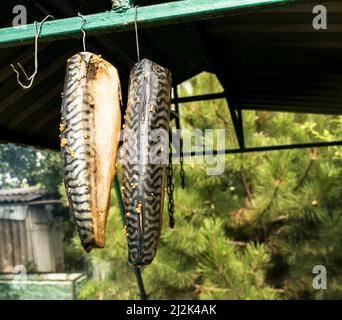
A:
[0,187,64,273]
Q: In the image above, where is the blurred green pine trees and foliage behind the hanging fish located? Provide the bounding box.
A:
[0,73,342,299]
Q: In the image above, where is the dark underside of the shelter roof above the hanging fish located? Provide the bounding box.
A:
[0,0,342,149]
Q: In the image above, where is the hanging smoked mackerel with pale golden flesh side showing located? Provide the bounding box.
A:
[60,52,121,252]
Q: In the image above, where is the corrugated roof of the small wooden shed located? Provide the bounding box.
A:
[0,187,46,204]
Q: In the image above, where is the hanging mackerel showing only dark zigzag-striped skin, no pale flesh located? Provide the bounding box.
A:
[122,59,171,267]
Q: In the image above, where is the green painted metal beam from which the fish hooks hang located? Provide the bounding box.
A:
[0,0,304,48]
